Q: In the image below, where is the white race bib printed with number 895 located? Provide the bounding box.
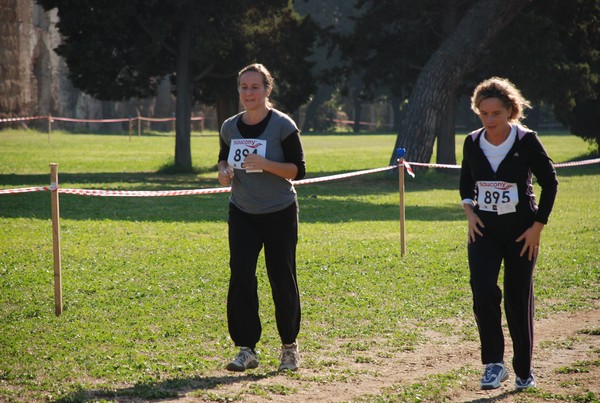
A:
[477,181,519,214]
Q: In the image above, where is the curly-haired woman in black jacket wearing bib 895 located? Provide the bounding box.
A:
[460,77,558,390]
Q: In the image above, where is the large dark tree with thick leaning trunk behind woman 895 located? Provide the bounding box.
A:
[340,0,600,163]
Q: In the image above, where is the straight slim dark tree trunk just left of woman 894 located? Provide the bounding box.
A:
[175,16,192,171]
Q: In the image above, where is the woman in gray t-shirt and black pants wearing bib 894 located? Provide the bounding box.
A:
[218,64,306,371]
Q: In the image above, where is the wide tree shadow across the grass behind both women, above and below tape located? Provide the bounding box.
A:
[0,158,600,223]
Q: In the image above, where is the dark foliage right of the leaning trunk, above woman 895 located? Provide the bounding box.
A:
[475,0,600,142]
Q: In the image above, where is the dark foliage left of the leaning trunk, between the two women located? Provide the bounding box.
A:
[339,0,466,98]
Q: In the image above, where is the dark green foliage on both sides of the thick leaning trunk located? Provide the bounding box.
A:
[338,0,600,148]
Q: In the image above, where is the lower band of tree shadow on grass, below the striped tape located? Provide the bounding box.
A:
[0,188,463,226]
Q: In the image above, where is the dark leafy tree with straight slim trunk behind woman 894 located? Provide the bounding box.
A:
[37,0,317,170]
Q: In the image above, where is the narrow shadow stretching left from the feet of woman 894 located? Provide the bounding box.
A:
[56,371,280,403]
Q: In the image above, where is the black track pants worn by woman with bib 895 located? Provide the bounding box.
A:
[468,223,537,379]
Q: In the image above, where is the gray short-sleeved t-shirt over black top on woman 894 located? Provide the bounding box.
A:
[221,109,298,214]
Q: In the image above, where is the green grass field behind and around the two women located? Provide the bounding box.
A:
[0,131,600,401]
